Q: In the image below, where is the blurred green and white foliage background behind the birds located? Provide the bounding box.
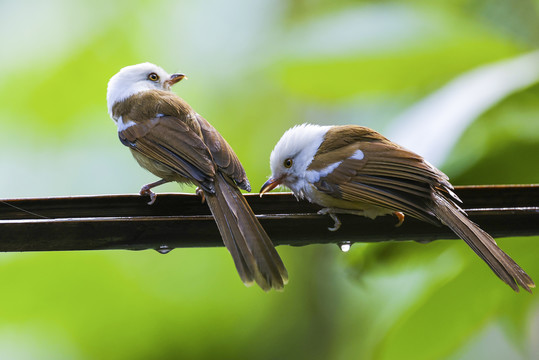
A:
[0,0,539,360]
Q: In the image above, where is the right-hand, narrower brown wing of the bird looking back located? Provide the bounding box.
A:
[196,114,251,191]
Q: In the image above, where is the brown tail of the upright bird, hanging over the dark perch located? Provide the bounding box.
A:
[205,174,288,291]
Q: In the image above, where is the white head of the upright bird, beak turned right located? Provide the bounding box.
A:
[107,63,186,113]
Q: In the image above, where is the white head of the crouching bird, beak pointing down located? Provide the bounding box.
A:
[260,124,330,196]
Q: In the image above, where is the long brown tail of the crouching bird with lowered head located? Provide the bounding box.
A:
[432,194,535,292]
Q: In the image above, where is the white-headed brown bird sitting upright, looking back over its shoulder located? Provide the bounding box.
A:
[107,63,288,291]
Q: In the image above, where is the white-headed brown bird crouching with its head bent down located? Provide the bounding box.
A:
[260,123,535,293]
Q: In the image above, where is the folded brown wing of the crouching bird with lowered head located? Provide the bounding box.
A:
[309,126,453,224]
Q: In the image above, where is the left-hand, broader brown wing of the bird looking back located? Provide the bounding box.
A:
[118,116,215,192]
